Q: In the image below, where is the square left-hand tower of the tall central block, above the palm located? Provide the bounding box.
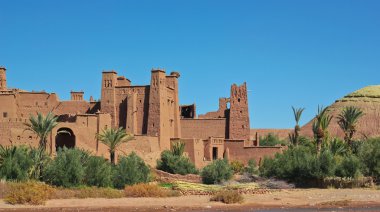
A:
[100,71,118,127]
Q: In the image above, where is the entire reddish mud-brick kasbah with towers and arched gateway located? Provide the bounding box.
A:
[0,67,281,167]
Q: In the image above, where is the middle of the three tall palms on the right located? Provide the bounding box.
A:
[312,106,333,154]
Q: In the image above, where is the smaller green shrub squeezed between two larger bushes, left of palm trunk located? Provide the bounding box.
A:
[85,156,112,187]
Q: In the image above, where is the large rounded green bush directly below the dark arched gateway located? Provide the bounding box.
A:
[44,148,89,187]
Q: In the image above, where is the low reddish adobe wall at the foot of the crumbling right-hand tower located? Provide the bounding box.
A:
[224,141,283,165]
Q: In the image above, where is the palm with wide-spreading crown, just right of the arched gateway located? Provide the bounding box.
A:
[97,127,133,164]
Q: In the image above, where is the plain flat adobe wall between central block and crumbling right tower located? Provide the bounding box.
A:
[180,118,226,139]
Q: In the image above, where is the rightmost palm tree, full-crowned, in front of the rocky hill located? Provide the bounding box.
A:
[338,106,364,149]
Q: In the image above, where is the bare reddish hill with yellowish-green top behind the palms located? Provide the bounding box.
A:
[301,85,380,138]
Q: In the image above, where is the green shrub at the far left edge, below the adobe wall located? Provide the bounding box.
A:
[0,146,33,181]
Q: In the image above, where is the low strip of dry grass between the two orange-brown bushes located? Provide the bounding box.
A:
[52,187,125,199]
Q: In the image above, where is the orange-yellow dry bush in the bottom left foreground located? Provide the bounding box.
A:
[4,182,54,205]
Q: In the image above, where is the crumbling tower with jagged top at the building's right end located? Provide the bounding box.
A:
[229,83,250,140]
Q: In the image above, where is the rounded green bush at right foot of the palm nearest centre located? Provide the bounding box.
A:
[114,152,151,188]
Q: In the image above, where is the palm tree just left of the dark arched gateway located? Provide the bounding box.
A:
[25,112,58,151]
